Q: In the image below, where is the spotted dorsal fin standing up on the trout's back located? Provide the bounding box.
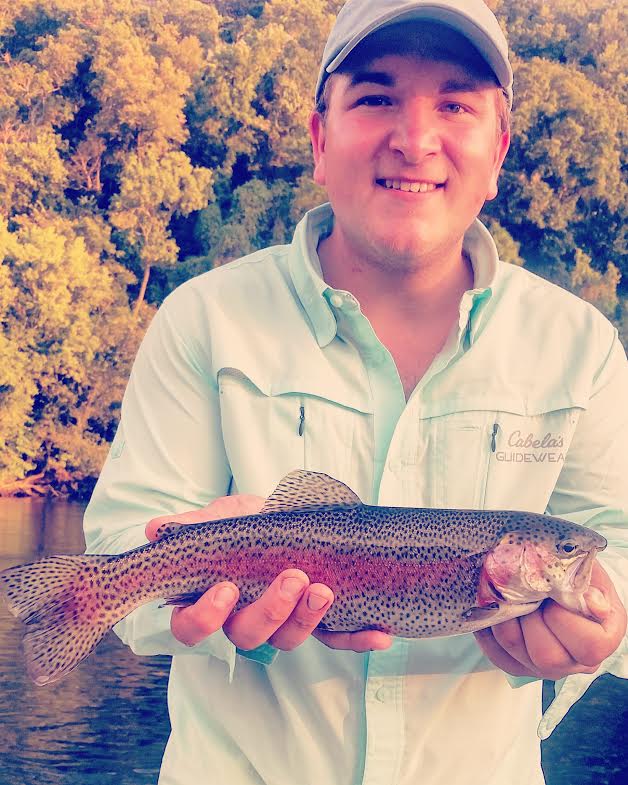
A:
[262,469,362,513]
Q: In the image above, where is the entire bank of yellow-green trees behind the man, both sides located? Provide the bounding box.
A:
[0,0,628,499]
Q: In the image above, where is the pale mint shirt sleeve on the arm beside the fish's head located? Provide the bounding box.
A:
[509,322,628,739]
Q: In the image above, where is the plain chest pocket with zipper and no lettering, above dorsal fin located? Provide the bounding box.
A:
[218,368,372,495]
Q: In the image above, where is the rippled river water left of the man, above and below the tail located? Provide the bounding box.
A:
[0,499,170,785]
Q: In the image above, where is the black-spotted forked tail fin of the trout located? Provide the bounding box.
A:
[0,556,117,685]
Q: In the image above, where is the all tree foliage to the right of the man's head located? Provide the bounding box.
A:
[487,0,628,316]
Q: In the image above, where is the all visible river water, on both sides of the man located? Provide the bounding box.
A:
[0,499,628,785]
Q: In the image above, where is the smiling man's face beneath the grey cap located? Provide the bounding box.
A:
[310,49,509,270]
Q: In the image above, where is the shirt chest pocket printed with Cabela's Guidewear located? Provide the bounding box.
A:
[418,398,582,512]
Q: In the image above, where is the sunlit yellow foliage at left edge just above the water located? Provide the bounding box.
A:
[0,213,146,490]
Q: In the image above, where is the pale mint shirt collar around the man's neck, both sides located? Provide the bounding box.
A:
[289,202,499,347]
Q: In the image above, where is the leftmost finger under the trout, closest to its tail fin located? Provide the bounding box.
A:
[170,581,239,646]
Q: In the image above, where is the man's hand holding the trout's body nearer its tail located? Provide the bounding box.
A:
[146,494,392,651]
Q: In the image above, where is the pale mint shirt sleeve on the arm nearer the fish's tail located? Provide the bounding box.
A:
[84,291,236,674]
